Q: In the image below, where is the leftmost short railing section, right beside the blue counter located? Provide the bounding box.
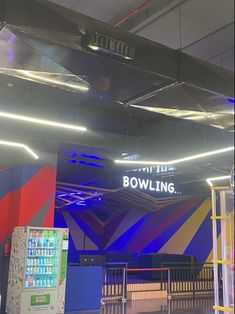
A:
[102,263,127,304]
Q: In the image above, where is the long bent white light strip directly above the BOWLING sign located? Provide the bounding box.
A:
[114,146,234,166]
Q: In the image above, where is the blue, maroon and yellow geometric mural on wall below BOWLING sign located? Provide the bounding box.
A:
[55,186,220,263]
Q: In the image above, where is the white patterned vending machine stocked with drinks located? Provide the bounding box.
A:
[6,227,68,314]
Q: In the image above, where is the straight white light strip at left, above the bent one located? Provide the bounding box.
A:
[0,111,87,132]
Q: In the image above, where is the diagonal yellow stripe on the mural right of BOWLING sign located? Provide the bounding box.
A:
[159,198,211,254]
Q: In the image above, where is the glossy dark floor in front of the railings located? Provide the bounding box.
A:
[1,298,214,314]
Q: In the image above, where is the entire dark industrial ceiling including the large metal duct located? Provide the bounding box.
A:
[0,0,234,191]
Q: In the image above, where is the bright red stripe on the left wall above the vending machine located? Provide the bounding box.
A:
[0,166,56,244]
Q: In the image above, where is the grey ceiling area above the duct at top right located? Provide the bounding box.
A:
[51,0,234,71]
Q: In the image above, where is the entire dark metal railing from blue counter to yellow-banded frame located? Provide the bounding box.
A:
[102,263,214,304]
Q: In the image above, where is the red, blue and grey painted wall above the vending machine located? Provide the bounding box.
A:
[0,165,56,245]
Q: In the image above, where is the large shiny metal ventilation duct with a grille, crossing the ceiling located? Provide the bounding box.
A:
[0,0,234,129]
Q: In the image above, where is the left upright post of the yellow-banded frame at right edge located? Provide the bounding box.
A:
[212,190,219,314]
